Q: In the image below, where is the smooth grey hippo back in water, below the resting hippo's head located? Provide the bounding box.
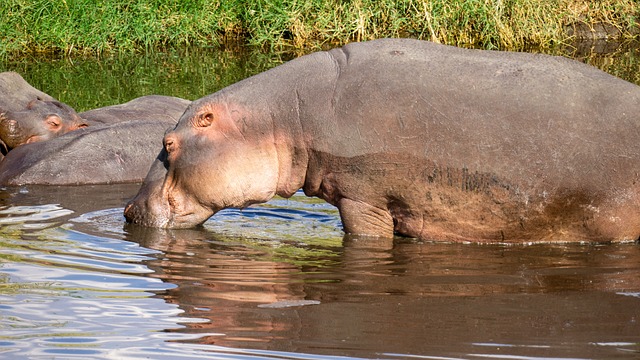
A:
[0,120,175,186]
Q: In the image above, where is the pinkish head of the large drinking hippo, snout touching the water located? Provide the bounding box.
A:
[125,98,282,228]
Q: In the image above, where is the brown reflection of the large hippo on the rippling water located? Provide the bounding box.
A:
[116,193,640,358]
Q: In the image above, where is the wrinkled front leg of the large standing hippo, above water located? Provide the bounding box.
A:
[338,198,393,238]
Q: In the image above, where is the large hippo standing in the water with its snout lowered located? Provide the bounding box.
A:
[124,39,640,243]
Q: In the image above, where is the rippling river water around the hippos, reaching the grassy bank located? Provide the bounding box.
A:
[0,41,640,359]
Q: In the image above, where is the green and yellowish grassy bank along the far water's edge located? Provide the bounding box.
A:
[0,0,640,56]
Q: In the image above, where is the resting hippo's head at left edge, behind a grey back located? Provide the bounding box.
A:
[0,99,87,150]
